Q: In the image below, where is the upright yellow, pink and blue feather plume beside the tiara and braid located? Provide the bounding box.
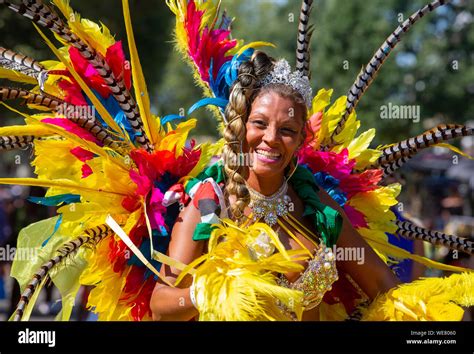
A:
[166,0,273,130]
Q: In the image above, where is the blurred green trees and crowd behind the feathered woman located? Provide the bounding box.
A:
[0,0,474,320]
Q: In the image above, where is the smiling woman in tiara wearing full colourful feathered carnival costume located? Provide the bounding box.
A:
[0,0,474,321]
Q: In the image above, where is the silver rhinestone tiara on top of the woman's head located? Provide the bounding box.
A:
[261,59,313,108]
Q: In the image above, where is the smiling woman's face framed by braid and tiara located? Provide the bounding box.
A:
[244,91,304,177]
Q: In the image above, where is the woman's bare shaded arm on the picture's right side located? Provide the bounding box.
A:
[318,189,400,299]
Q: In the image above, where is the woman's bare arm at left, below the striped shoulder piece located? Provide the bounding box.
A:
[150,199,204,321]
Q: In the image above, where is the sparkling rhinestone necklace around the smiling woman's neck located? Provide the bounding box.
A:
[247,179,291,226]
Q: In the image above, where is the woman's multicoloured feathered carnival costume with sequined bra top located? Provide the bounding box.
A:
[0,0,474,321]
